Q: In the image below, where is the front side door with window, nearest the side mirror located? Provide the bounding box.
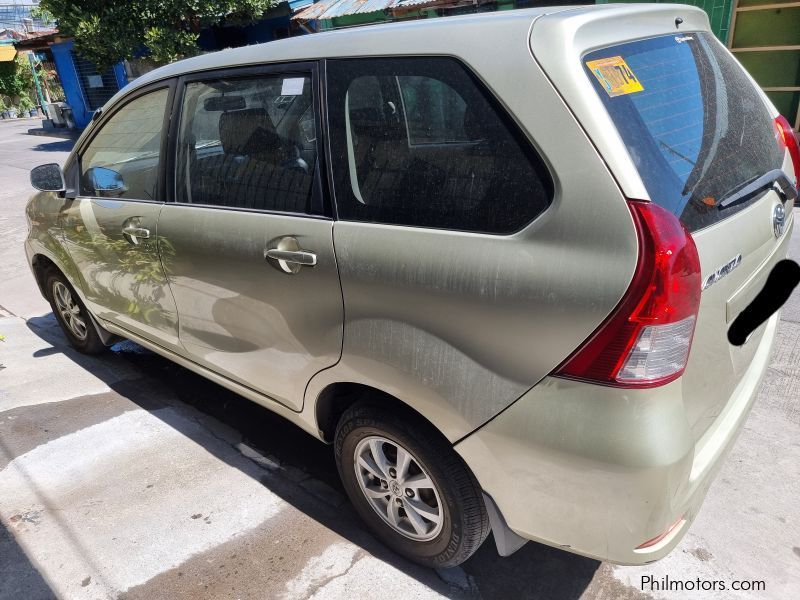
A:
[61,83,180,350]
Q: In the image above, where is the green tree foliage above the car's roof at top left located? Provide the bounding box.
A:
[40,0,276,69]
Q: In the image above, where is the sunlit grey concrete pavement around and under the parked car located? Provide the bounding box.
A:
[0,122,800,600]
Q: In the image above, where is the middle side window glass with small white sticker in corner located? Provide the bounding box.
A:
[175,74,317,213]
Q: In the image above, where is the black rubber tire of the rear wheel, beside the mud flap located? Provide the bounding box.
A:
[334,403,489,568]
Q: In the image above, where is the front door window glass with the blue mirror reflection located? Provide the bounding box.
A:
[80,88,169,200]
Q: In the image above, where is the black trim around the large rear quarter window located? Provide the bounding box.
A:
[322,54,556,238]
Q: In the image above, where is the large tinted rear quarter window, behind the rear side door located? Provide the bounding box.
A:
[327,58,552,233]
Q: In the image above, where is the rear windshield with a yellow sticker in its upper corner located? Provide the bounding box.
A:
[583,33,783,231]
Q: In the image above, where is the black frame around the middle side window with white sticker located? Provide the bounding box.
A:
[164,60,333,220]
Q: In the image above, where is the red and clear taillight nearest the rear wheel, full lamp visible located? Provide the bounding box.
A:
[554,200,700,387]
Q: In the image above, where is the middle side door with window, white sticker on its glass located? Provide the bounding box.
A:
[158,64,343,410]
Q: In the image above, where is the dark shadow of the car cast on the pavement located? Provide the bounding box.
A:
[20,315,601,600]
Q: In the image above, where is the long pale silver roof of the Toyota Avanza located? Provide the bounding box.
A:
[92,4,708,159]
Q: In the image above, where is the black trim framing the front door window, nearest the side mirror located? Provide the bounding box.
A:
[75,77,177,204]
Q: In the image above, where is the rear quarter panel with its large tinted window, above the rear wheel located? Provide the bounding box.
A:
[318,56,636,440]
